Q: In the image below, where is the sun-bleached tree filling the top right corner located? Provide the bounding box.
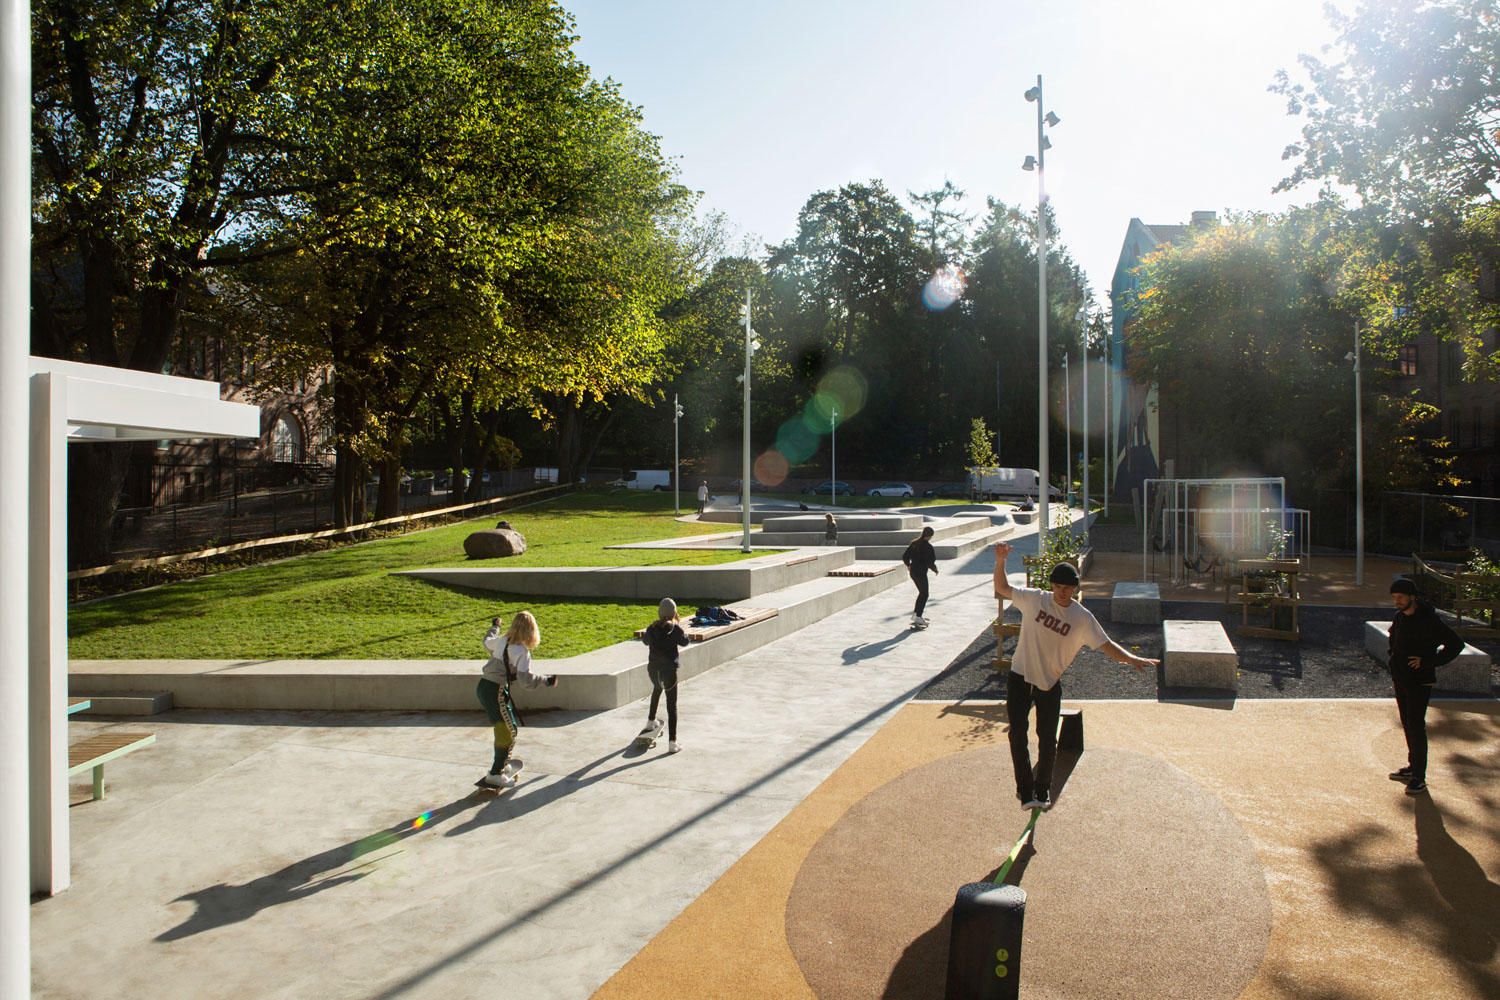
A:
[1272,0,1500,378]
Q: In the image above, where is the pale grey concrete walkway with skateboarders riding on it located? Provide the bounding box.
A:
[32,527,1034,1000]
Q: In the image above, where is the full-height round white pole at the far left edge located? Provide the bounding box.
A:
[0,0,32,997]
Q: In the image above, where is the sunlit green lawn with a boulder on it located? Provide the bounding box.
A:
[68,490,762,660]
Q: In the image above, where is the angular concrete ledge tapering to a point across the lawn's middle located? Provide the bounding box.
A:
[392,546,855,604]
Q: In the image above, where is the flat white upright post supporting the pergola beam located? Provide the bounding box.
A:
[27,373,71,895]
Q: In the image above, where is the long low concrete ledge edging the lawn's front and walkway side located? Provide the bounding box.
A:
[68,563,906,712]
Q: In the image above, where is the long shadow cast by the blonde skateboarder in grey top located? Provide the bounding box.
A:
[156,792,486,942]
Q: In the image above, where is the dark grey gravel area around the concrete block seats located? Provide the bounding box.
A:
[918,598,1500,702]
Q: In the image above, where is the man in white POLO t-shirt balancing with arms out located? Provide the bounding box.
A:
[995,541,1160,810]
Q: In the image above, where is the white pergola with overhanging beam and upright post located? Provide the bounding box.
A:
[27,357,261,894]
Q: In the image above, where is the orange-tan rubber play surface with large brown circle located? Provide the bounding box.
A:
[596,702,1500,1000]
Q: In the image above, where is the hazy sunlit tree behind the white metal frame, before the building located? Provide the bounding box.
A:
[1127,198,1443,496]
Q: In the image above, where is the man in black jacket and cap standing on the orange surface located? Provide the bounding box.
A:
[1388,580,1464,795]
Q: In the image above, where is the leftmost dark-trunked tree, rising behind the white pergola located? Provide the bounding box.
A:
[32,0,327,565]
